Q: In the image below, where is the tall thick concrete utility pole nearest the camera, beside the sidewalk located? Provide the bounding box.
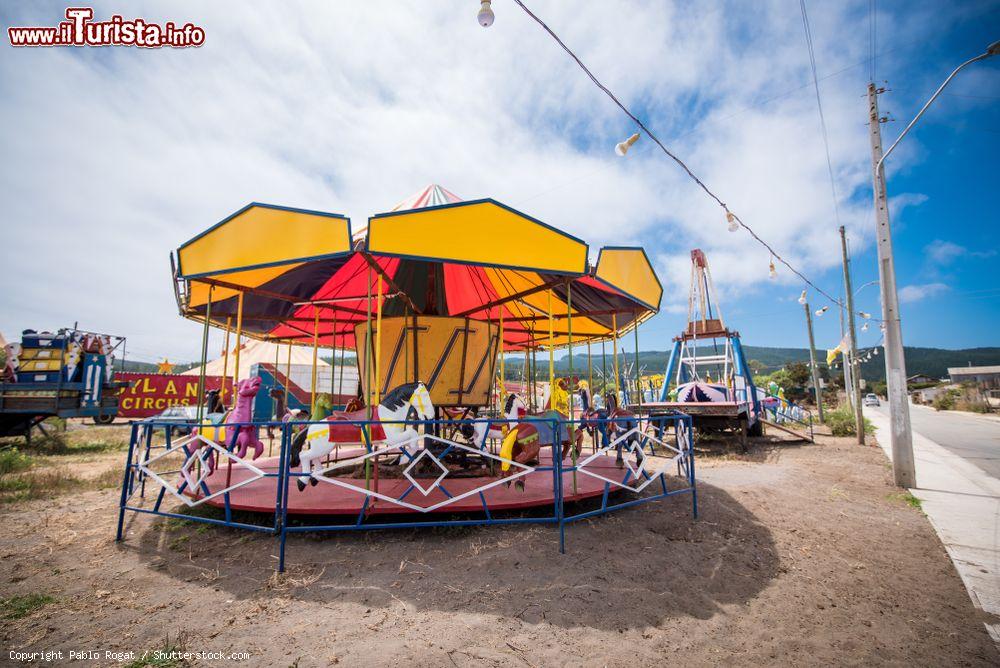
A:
[868,82,916,487]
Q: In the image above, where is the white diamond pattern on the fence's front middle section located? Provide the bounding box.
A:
[311,434,535,513]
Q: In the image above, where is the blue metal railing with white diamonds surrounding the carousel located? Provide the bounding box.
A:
[116,414,698,572]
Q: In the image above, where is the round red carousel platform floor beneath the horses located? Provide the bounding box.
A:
[184,452,628,516]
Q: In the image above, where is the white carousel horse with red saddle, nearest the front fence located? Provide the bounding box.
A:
[289,382,434,492]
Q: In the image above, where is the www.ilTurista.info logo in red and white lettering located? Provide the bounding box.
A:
[7,7,205,49]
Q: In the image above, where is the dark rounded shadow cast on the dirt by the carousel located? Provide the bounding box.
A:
[125,484,779,630]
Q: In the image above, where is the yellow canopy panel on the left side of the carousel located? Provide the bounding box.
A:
[177,203,351,279]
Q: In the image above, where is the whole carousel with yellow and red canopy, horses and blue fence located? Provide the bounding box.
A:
[119,186,694,563]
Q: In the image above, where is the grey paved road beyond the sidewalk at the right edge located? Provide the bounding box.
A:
[866,402,1000,480]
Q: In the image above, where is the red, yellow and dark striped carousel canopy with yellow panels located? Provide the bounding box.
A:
[171,185,662,351]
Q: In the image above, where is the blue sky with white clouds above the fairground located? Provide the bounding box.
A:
[0,0,1000,361]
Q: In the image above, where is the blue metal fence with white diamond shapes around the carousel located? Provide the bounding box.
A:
[116,414,698,571]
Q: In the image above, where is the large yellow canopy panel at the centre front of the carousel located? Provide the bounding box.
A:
[368,199,587,275]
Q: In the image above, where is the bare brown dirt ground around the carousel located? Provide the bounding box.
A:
[0,428,1000,667]
